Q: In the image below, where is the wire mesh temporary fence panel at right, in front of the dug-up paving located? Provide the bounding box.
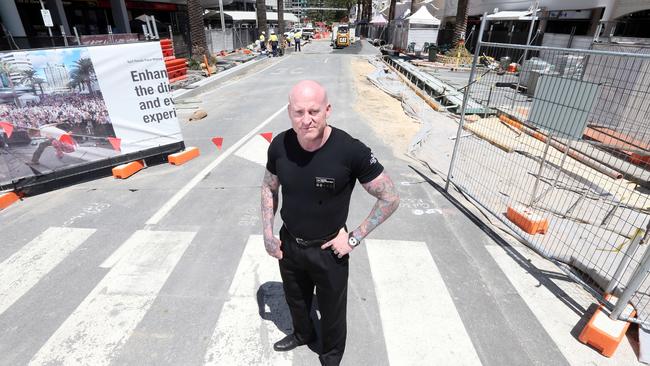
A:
[448,14,650,325]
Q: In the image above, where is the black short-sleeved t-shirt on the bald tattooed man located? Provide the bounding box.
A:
[266,127,384,240]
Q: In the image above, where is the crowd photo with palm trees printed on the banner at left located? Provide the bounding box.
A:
[0,48,119,183]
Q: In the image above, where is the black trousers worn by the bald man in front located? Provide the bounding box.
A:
[280,226,350,366]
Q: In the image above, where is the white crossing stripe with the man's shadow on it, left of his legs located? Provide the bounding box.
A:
[204,235,293,366]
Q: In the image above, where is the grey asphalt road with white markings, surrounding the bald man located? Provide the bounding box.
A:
[0,41,636,366]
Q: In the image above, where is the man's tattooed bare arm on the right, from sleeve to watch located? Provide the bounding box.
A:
[354,173,399,239]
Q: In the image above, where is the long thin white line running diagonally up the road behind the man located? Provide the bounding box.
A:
[145,105,287,225]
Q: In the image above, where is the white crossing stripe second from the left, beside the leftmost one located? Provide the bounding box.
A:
[30,230,196,366]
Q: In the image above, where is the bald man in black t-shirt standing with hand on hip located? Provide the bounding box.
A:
[262,80,399,365]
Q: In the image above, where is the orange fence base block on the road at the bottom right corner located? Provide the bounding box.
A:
[578,295,636,357]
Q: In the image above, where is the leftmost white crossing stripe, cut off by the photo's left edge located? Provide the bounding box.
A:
[0,227,96,314]
